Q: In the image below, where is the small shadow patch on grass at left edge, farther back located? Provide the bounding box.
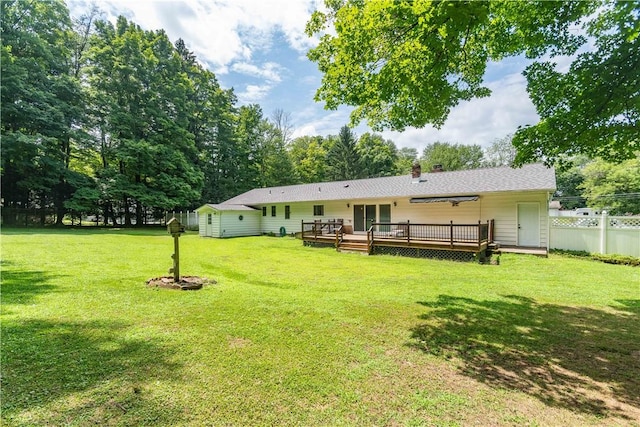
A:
[0,261,59,314]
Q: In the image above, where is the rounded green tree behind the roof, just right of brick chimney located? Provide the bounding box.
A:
[421,142,483,171]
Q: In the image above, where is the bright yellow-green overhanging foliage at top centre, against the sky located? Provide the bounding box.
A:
[307,0,596,130]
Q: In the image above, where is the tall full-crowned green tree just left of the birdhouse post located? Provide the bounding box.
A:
[87,17,203,225]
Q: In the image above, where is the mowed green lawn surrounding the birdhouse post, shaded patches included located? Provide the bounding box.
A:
[1,229,640,426]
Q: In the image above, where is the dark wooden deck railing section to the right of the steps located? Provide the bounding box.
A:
[367,220,493,247]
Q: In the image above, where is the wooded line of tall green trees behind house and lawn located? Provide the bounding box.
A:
[1,1,516,225]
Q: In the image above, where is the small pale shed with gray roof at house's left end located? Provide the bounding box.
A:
[196,204,261,238]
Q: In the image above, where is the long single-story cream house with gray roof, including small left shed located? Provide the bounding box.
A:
[197,164,556,248]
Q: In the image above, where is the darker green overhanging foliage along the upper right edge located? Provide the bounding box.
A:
[514,1,640,164]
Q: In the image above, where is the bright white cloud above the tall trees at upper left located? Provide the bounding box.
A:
[68,0,315,69]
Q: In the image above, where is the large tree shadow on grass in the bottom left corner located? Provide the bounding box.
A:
[1,320,184,425]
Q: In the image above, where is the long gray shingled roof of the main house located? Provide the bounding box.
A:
[221,164,556,206]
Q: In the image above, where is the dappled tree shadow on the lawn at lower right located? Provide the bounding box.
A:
[411,295,640,419]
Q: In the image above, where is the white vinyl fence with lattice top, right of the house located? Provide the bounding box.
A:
[549,212,640,257]
